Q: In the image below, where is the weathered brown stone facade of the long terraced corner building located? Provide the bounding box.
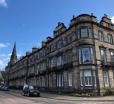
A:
[6,14,114,94]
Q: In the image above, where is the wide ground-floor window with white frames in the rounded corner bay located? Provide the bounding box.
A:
[80,70,96,86]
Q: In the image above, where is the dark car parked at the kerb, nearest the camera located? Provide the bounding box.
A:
[23,86,40,97]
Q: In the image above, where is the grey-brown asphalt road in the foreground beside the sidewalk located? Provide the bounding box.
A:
[0,91,114,104]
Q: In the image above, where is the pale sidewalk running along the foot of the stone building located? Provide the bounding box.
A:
[10,90,114,102]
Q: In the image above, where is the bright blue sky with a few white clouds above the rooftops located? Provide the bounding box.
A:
[0,0,114,70]
